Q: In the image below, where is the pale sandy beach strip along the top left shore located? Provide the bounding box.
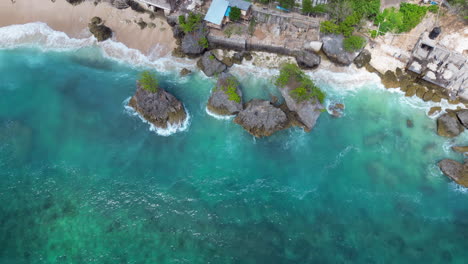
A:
[0,0,176,58]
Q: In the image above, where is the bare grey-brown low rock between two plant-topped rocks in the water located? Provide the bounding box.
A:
[234,99,288,137]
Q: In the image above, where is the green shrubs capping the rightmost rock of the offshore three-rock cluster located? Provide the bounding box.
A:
[275,63,326,103]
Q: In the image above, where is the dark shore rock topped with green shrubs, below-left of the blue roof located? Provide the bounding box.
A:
[179,13,208,55]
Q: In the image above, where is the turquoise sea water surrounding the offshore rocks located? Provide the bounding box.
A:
[0,45,468,263]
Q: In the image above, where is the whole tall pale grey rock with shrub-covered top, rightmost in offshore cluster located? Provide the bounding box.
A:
[276,64,325,131]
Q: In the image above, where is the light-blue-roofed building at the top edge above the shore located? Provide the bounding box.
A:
[205,0,252,29]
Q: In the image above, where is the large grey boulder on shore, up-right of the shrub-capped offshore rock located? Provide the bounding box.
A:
[322,35,361,66]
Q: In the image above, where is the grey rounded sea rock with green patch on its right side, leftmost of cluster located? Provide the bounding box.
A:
[207,73,242,115]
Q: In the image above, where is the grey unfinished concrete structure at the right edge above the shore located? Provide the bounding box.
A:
[407,32,468,100]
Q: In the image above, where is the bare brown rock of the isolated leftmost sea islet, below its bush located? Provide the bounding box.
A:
[128,84,187,128]
